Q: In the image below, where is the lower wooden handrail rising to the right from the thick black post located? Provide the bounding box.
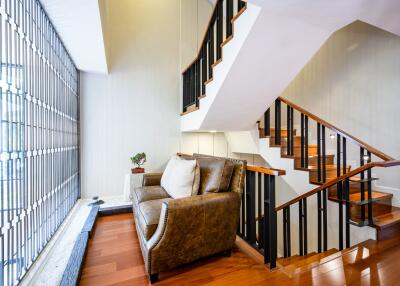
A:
[275,160,400,211]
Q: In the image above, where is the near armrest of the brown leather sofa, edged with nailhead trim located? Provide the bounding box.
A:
[147,192,240,274]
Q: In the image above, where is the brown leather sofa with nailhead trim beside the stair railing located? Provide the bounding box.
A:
[132,154,246,282]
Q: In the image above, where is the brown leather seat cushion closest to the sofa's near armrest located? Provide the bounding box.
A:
[136,198,172,240]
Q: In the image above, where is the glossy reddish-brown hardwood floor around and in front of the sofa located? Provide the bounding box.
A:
[80,214,400,286]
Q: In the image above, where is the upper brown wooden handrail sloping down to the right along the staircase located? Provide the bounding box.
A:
[278,97,395,161]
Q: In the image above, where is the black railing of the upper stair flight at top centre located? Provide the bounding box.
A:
[182,0,246,114]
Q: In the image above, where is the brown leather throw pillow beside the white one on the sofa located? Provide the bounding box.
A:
[197,158,234,195]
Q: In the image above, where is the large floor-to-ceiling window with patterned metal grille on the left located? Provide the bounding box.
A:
[0,0,80,285]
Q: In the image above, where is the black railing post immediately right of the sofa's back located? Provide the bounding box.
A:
[246,171,256,245]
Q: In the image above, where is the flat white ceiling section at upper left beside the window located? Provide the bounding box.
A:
[40,0,108,73]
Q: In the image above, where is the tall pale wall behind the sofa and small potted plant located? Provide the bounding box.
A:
[81,0,180,197]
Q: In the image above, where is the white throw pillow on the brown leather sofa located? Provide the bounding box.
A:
[161,156,197,199]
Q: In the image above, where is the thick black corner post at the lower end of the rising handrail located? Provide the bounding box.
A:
[264,174,278,269]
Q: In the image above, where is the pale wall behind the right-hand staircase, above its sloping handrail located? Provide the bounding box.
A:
[282,22,400,201]
